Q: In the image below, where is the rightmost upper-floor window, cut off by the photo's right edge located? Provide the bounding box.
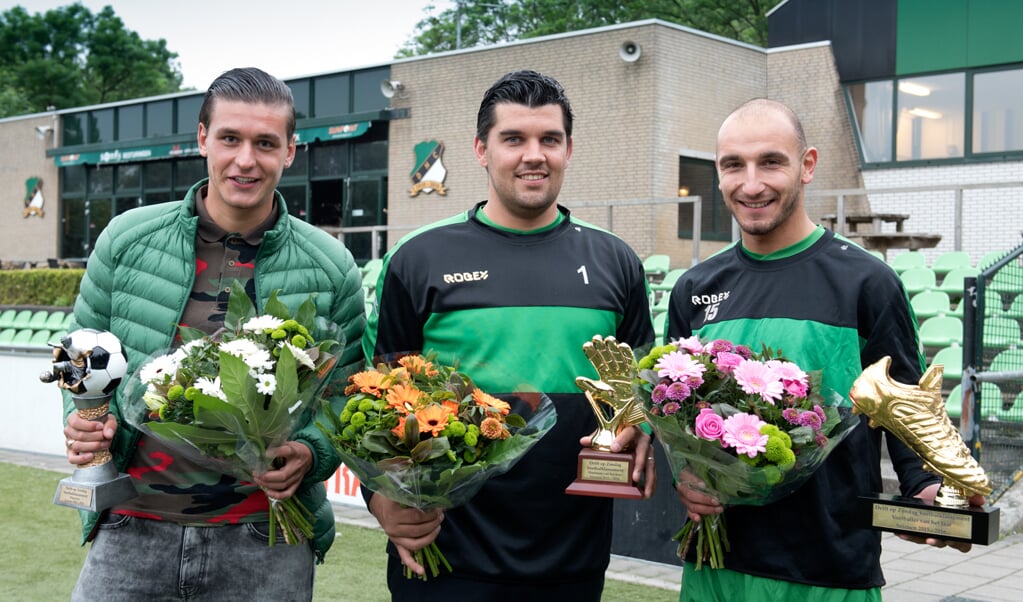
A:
[973,69,1023,153]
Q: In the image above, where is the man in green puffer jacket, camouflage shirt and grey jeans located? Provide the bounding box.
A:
[64,69,365,600]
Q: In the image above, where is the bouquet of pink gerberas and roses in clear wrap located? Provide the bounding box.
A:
[637,337,859,569]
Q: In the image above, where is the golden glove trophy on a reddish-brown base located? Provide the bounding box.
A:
[565,335,647,500]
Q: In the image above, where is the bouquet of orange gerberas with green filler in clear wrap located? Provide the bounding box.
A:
[321,354,558,579]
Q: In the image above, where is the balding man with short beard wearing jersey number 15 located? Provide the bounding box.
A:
[667,98,983,602]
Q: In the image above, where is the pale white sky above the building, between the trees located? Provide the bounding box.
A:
[12,0,453,90]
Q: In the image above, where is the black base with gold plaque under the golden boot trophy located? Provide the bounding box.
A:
[856,493,999,546]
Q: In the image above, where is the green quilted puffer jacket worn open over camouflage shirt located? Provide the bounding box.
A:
[64,180,365,562]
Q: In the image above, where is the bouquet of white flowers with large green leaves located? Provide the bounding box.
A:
[122,286,344,546]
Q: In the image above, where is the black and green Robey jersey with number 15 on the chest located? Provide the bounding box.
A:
[667,227,937,589]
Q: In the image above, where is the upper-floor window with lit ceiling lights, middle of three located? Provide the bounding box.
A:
[895,73,966,161]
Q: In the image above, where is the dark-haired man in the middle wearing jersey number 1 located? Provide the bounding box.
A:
[363,71,654,602]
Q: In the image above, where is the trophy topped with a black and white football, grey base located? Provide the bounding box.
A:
[39,329,138,512]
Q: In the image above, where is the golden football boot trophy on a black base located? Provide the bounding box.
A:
[849,356,998,546]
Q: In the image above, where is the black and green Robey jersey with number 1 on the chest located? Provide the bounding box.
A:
[363,203,654,587]
